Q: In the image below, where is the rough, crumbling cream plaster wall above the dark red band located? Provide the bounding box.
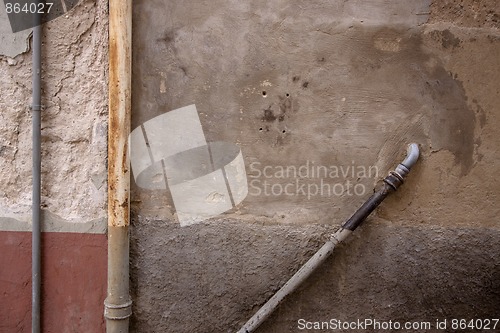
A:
[0,1,108,233]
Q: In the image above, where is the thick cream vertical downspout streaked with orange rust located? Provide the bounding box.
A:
[104,0,132,333]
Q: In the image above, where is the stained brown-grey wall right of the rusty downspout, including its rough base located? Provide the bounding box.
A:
[131,0,500,332]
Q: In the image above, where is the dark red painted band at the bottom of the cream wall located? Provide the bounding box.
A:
[0,231,107,333]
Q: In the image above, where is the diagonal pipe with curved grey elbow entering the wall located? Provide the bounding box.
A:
[238,144,419,333]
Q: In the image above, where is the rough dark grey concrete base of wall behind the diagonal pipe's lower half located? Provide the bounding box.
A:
[131,218,500,333]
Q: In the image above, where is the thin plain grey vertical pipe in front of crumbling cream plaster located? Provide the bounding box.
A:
[31,20,42,333]
